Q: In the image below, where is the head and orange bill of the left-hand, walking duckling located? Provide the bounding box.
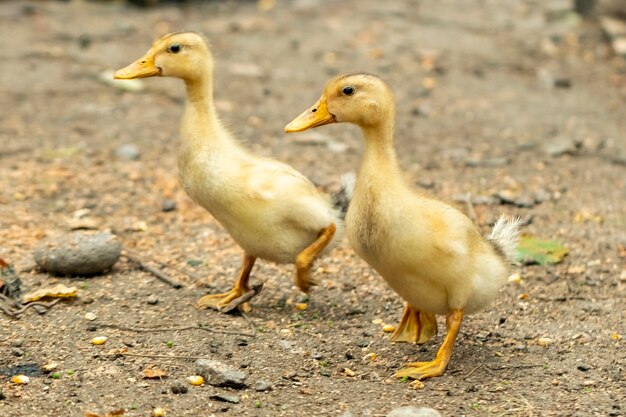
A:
[114,32,213,81]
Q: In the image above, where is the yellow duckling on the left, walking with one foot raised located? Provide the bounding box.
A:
[115,32,349,311]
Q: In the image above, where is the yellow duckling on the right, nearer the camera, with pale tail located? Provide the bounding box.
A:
[285,74,520,380]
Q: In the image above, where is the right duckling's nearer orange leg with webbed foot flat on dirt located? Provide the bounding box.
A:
[395,310,463,380]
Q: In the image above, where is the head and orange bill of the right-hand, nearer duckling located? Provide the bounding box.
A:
[285,73,395,132]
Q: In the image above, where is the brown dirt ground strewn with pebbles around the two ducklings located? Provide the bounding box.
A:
[0,0,626,417]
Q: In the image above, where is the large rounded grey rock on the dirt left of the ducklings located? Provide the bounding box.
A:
[34,231,122,276]
